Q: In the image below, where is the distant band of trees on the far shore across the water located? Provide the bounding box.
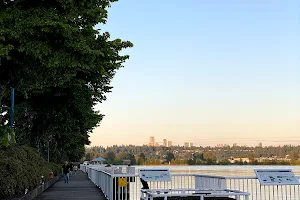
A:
[85,145,300,165]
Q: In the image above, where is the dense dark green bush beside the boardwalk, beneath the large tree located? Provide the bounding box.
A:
[0,144,60,199]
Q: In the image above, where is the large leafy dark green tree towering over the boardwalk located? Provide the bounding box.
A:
[0,0,132,160]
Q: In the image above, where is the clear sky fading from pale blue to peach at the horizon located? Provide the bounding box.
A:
[90,0,300,146]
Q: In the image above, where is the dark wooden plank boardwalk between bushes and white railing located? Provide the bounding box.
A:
[35,171,106,200]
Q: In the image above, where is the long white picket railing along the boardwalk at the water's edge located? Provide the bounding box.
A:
[80,165,300,200]
